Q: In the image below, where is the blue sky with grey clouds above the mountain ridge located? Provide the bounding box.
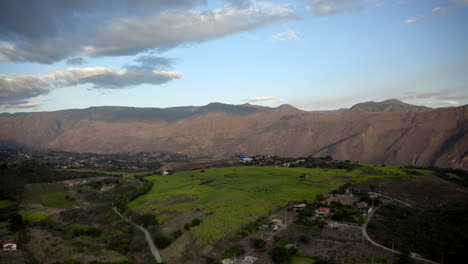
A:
[0,0,468,113]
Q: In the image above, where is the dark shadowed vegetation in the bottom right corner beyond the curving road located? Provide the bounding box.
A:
[368,201,468,263]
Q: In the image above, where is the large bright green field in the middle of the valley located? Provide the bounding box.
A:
[129,164,427,243]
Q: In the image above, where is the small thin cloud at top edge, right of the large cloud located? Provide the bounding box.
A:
[307,0,379,17]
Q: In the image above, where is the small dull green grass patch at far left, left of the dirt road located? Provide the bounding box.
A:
[23,183,79,209]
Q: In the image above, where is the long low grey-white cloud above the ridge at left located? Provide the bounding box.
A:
[0,67,183,105]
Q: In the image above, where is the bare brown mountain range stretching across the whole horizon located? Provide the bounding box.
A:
[0,100,468,169]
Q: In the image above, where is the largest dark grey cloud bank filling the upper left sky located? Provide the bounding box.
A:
[0,0,294,63]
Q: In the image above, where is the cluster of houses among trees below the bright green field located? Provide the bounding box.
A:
[221,188,382,264]
